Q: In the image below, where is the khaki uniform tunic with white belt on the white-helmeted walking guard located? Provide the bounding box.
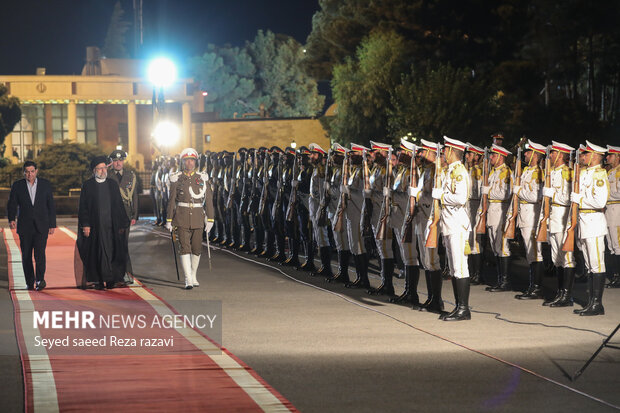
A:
[168,172,214,255]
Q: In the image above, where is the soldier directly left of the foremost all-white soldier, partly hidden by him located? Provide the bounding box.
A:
[409,139,444,313]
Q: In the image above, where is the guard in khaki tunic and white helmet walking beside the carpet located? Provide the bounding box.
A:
[166,148,213,289]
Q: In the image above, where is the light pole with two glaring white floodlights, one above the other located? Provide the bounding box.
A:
[147,57,179,152]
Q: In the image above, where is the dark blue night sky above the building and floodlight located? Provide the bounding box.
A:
[0,0,319,75]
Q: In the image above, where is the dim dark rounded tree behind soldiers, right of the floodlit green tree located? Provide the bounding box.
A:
[388,65,498,143]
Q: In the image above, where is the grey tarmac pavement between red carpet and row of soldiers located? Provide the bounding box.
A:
[0,219,620,412]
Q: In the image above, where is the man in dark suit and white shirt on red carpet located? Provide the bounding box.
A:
[7,161,56,291]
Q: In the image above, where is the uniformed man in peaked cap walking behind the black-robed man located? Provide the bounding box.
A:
[108,149,138,284]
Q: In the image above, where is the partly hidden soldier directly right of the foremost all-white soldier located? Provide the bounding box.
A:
[465,143,484,285]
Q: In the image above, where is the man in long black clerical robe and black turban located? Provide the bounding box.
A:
[75,156,130,289]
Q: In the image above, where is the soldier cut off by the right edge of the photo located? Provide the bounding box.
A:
[605,145,620,288]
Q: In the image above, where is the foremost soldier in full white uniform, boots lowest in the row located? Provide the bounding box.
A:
[432,136,471,321]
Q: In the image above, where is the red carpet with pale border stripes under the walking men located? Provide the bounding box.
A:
[4,228,296,412]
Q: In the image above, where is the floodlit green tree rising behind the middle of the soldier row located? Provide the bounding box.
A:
[329,31,410,144]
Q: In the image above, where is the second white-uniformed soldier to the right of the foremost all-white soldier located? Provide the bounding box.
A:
[481,144,512,292]
